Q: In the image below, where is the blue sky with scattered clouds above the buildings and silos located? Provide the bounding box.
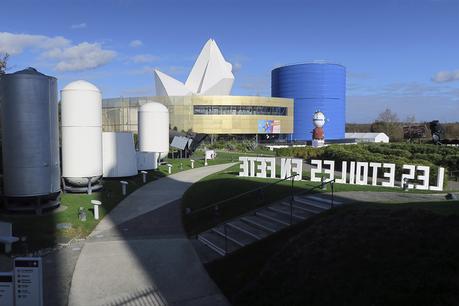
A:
[0,0,459,122]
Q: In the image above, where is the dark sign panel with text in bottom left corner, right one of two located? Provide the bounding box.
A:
[14,257,43,306]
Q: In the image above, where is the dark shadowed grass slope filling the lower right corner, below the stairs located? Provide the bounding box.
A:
[206,201,459,306]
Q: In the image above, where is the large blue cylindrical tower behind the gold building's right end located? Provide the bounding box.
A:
[271,63,346,140]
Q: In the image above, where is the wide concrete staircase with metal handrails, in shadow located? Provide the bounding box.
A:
[195,194,343,261]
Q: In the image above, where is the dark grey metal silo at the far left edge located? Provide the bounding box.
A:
[0,68,61,212]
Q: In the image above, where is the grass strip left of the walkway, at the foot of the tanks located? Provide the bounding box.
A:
[0,151,240,253]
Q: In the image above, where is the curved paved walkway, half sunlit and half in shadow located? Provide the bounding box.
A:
[69,164,232,306]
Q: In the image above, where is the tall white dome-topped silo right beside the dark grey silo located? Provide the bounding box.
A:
[61,80,103,192]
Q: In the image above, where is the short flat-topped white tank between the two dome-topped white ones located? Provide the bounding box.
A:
[102,132,137,177]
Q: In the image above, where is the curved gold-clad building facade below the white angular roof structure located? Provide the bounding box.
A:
[102,96,293,134]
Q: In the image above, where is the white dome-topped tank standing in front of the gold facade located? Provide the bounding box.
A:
[138,102,169,159]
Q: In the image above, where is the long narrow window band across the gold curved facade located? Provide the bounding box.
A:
[193,105,287,116]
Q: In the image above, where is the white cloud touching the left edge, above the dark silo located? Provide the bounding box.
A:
[0,32,71,55]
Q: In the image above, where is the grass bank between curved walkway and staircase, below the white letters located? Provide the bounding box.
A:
[182,165,448,235]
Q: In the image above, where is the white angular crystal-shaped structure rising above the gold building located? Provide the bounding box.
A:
[155,39,234,96]
